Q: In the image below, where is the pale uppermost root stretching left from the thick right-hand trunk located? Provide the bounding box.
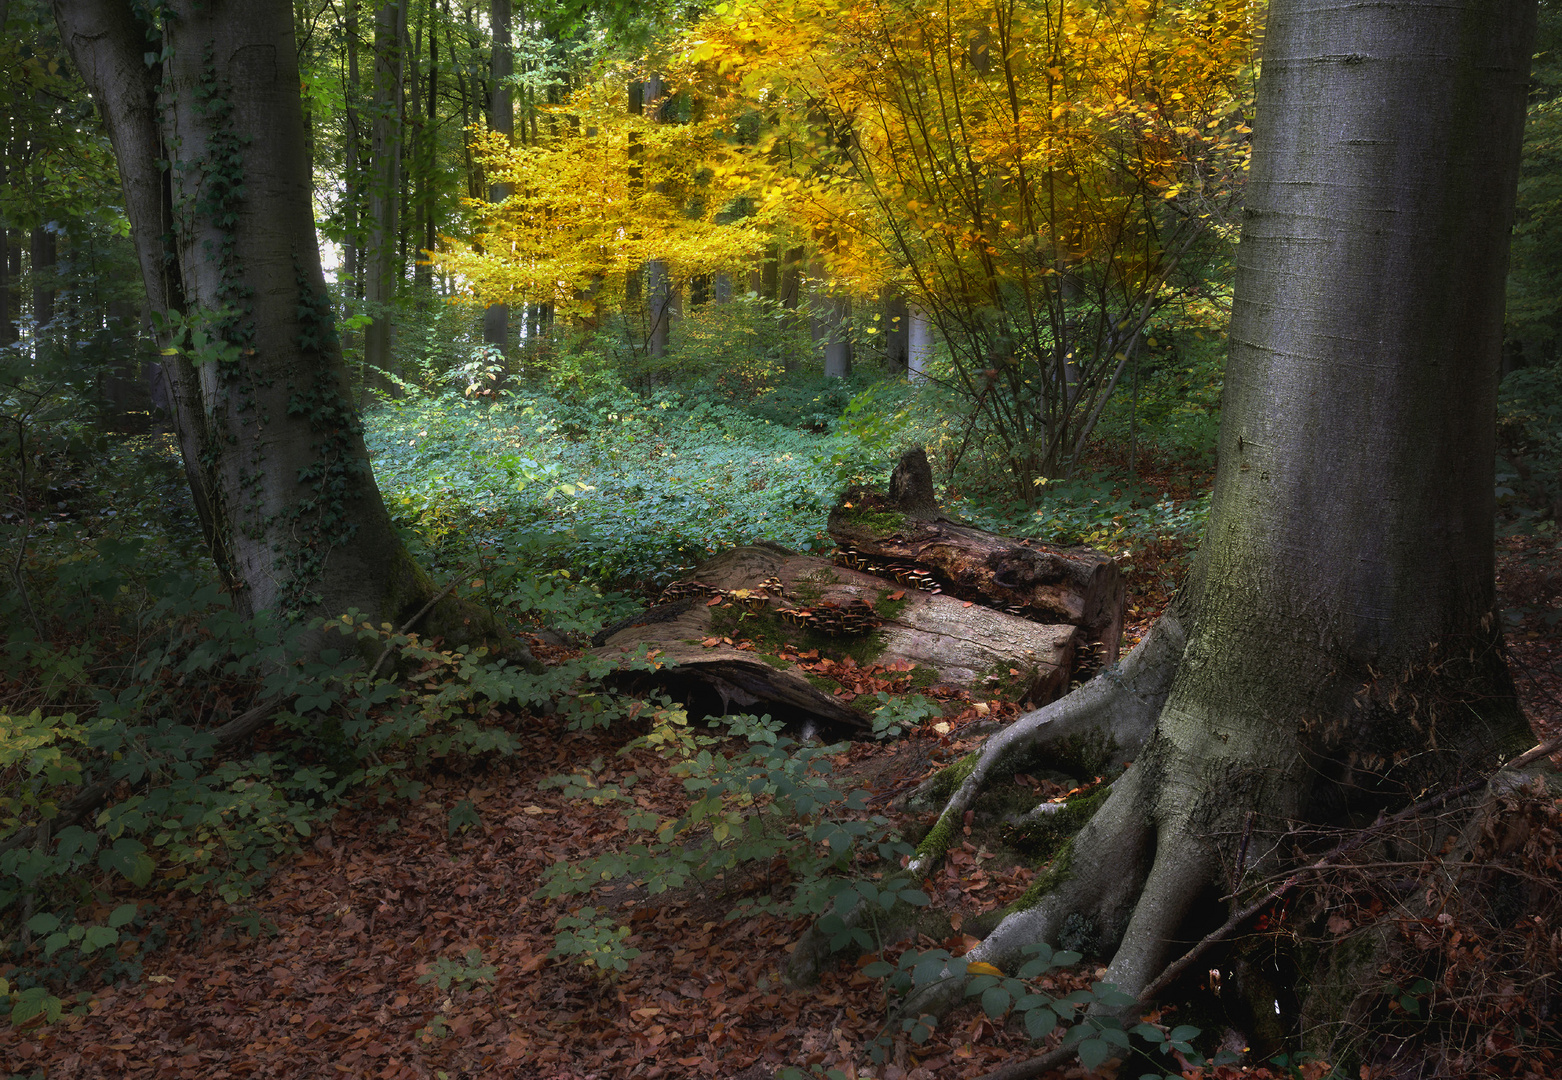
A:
[908,613,1186,874]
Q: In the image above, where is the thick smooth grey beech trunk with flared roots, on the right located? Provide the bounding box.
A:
[824,0,1534,1050]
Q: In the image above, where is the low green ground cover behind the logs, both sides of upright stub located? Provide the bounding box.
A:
[367,370,1207,588]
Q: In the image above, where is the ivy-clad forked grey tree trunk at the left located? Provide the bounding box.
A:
[55,0,524,662]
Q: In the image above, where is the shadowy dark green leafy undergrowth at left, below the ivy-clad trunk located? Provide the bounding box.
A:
[0,509,659,1024]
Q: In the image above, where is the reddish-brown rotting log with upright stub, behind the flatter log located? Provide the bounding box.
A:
[829,447,1123,663]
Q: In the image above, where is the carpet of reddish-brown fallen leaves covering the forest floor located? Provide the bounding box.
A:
[0,522,1562,1080]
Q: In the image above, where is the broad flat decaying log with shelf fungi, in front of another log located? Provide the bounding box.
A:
[595,544,1079,730]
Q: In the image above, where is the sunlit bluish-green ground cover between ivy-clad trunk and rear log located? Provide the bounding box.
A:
[367,373,949,583]
